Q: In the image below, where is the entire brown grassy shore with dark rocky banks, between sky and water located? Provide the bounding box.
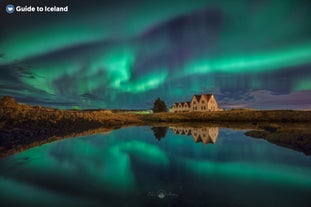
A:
[0,97,311,158]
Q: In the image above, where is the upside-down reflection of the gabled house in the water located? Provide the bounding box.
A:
[170,127,219,144]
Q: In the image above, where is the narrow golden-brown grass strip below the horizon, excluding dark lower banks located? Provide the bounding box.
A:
[0,97,311,125]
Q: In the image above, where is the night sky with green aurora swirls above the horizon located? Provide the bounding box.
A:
[0,0,311,109]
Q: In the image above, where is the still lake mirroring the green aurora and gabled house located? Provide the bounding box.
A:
[0,126,311,207]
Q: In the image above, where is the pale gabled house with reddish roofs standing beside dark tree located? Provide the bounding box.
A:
[169,94,221,112]
